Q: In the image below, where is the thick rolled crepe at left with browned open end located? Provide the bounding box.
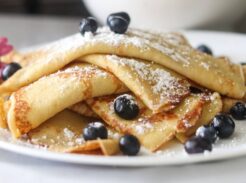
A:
[7,63,128,137]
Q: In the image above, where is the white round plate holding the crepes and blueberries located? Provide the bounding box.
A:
[0,31,246,166]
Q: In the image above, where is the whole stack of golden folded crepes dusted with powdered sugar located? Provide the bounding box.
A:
[0,27,245,155]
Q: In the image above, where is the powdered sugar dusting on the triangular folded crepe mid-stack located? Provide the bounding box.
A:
[107,55,188,106]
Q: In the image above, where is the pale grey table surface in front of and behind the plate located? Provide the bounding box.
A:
[0,15,246,183]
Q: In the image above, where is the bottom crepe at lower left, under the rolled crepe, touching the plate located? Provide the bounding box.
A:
[27,110,119,155]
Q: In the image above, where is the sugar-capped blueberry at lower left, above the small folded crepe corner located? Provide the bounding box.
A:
[83,122,108,140]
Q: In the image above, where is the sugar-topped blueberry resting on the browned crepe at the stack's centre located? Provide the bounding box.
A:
[114,94,139,120]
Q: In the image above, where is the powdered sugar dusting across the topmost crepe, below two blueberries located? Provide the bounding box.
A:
[36,27,208,67]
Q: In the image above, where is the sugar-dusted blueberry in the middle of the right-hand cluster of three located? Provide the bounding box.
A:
[196,126,217,143]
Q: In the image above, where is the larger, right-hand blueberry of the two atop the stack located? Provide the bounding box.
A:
[107,12,130,34]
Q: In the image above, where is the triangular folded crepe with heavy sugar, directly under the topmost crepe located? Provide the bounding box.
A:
[80,55,190,112]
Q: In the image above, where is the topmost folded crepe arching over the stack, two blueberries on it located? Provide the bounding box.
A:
[0,27,245,98]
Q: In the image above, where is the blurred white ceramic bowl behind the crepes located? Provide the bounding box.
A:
[83,0,246,30]
